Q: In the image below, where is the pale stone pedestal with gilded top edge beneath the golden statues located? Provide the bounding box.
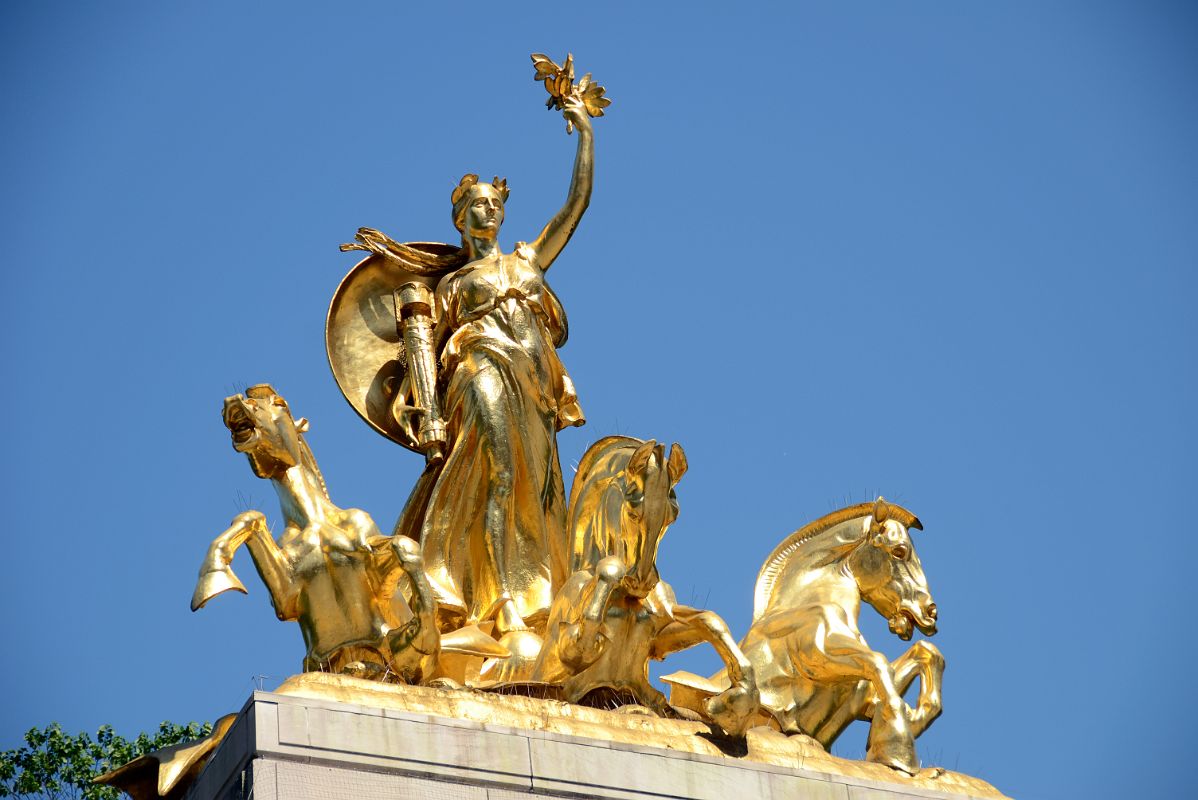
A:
[187,675,1003,800]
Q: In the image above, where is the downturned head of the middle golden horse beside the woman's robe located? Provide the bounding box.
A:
[615,440,686,598]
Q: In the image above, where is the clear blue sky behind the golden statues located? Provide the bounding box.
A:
[0,1,1198,798]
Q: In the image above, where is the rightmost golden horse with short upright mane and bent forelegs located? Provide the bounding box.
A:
[665,497,944,775]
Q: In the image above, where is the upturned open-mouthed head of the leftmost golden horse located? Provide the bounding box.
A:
[222,383,315,478]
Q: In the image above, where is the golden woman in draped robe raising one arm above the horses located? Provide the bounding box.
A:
[355,96,594,634]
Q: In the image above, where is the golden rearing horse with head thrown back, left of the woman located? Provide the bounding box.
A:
[192,383,507,683]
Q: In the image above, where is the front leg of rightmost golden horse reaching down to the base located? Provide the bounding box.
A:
[805,634,919,775]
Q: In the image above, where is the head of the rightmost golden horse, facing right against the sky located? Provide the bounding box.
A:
[849,497,937,641]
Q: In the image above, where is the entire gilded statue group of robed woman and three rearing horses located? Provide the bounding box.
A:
[192,54,944,774]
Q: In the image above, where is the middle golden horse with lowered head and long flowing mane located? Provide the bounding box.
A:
[530,436,757,735]
